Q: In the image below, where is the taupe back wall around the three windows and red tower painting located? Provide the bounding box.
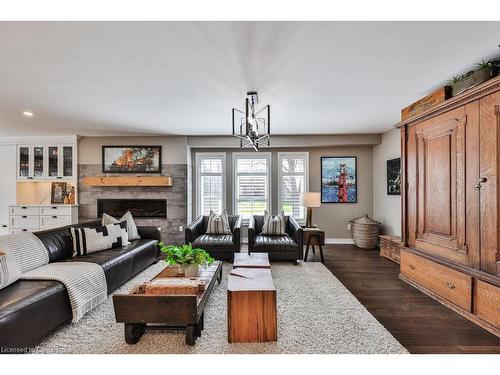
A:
[191,145,373,238]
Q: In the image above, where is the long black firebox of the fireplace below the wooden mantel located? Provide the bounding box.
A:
[97,199,167,218]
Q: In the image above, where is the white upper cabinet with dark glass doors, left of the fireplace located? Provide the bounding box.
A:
[17,144,76,180]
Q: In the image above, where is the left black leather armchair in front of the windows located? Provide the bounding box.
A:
[185,215,242,261]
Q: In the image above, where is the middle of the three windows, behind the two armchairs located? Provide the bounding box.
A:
[233,152,271,220]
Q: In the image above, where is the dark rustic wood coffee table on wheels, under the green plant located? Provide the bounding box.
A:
[113,261,222,345]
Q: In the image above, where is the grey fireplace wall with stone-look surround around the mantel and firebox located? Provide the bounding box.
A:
[78,137,188,243]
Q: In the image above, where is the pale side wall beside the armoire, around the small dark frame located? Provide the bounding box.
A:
[373,129,401,236]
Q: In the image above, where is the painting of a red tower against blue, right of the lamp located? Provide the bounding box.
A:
[321,156,358,203]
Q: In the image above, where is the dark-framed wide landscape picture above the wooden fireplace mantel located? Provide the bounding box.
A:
[102,146,161,174]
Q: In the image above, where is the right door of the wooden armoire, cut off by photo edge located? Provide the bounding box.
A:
[477,92,500,276]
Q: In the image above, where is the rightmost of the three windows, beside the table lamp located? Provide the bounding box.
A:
[278,152,309,222]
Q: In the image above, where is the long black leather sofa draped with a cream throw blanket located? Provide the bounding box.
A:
[0,221,160,352]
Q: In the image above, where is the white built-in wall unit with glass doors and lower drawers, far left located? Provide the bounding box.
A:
[0,136,78,235]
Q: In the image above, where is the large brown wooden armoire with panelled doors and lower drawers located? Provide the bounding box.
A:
[399,78,500,335]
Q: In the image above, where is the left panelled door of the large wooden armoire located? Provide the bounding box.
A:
[409,107,478,265]
